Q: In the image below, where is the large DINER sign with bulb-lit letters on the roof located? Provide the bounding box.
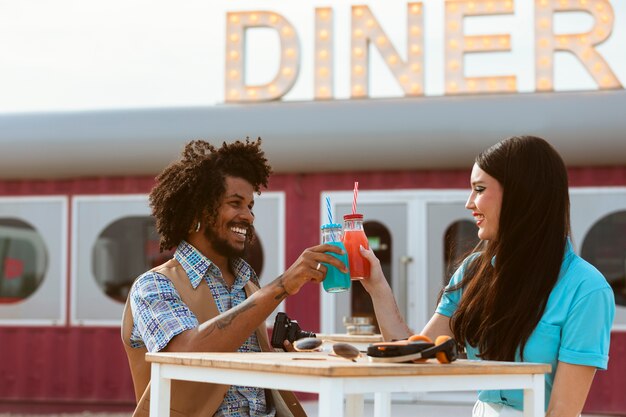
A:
[224,0,626,103]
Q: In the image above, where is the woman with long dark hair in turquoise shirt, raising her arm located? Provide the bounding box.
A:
[361,136,615,417]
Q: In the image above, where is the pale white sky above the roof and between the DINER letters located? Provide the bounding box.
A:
[0,0,626,114]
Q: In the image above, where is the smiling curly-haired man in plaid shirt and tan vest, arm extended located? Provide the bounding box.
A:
[122,138,346,417]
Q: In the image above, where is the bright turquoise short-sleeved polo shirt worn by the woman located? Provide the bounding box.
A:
[436,240,615,410]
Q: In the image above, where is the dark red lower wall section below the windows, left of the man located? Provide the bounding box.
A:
[0,327,135,413]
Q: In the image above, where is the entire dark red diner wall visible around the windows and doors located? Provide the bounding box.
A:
[0,167,626,414]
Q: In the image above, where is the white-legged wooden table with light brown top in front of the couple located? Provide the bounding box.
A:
[146,352,550,417]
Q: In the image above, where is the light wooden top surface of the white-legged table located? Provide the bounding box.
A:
[146,352,550,377]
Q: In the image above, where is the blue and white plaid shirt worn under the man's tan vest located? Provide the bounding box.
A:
[130,241,276,417]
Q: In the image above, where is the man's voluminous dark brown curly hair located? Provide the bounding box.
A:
[150,138,272,251]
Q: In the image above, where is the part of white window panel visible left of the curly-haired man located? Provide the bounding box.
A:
[70,194,152,326]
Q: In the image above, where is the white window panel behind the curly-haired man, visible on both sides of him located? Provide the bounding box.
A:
[70,193,284,326]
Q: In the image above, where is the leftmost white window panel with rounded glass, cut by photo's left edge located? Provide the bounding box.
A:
[0,196,68,326]
